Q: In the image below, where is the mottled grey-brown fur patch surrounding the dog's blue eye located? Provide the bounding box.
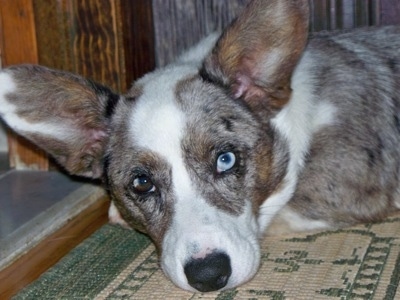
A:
[176,77,287,215]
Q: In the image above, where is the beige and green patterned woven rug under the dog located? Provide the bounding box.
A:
[15,215,400,300]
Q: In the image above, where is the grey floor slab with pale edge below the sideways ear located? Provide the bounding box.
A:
[0,168,98,269]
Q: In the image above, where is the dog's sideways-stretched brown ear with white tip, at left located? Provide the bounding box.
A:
[0,65,120,178]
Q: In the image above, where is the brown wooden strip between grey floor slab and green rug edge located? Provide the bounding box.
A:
[0,196,109,299]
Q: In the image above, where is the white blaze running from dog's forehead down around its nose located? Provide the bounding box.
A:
[130,68,260,291]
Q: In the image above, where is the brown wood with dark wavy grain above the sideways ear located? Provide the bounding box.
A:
[34,0,122,91]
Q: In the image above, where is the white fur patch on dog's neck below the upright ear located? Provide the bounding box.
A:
[259,53,336,231]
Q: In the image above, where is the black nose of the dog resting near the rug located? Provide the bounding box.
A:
[184,252,232,292]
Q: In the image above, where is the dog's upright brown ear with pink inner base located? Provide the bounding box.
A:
[201,0,309,109]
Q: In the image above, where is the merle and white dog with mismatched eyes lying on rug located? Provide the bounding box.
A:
[0,0,400,292]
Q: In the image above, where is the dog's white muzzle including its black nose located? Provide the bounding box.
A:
[161,198,260,292]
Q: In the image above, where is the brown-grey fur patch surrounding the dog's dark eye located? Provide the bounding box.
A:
[107,114,174,251]
